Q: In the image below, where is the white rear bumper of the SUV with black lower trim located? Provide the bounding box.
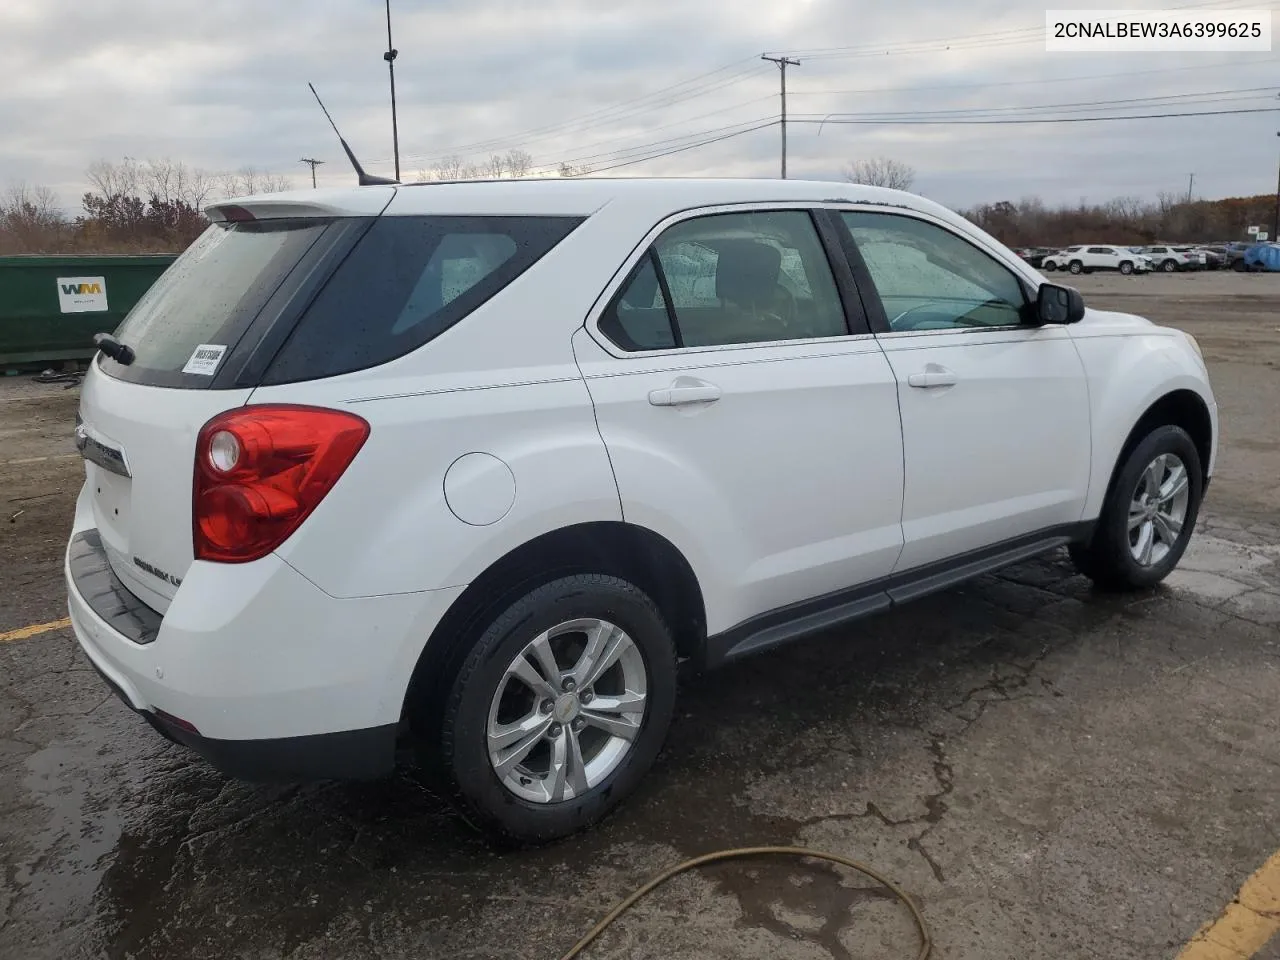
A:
[64,483,462,780]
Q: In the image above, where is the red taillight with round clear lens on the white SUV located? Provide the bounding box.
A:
[192,404,369,563]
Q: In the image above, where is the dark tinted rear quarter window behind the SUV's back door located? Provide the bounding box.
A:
[264,216,581,384]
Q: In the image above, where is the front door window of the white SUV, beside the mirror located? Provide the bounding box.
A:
[841,212,1027,330]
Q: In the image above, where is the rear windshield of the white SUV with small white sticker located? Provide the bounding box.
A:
[100,218,332,387]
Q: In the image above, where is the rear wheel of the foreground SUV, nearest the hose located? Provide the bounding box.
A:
[424,575,676,844]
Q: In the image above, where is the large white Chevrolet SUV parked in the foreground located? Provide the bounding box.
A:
[65,179,1217,841]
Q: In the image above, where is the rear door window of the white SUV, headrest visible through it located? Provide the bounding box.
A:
[600,210,849,351]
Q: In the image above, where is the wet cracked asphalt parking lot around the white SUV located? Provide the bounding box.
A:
[0,274,1280,960]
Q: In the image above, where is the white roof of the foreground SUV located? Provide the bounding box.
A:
[209,177,954,219]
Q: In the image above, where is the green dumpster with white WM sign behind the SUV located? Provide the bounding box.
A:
[0,255,175,367]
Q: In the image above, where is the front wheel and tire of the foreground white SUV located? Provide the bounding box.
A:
[1070,425,1204,590]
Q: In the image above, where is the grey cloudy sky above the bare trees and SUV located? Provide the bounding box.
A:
[0,0,1280,209]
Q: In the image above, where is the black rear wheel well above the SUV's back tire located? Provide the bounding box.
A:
[403,521,707,730]
